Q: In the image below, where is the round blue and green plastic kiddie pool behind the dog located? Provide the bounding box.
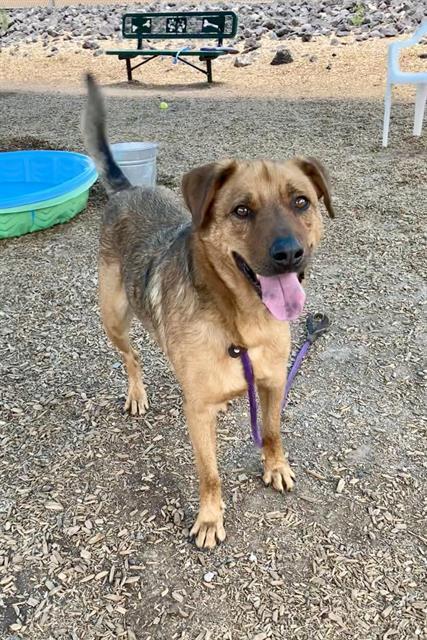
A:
[0,151,98,238]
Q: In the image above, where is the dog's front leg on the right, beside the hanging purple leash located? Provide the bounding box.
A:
[258,386,295,491]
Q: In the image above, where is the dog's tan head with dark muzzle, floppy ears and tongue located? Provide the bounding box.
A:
[182,158,334,320]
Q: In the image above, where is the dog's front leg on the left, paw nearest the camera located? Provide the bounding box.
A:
[185,399,225,549]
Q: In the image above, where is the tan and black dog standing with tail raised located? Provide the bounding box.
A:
[84,75,334,549]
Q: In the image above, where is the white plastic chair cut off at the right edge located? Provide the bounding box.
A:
[383,22,427,147]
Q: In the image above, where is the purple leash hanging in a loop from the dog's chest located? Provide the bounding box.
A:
[234,313,330,449]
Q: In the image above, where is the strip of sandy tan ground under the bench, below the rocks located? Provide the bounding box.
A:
[0,37,427,100]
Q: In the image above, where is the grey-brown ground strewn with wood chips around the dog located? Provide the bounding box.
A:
[0,87,427,640]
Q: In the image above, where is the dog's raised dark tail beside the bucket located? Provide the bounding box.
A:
[83,73,131,195]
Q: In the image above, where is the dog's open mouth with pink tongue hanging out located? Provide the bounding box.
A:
[233,253,305,320]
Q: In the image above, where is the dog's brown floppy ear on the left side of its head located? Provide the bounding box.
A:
[181,160,237,229]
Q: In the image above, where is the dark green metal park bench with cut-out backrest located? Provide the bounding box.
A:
[105,11,241,83]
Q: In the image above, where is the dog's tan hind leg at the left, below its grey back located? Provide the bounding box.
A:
[99,259,148,415]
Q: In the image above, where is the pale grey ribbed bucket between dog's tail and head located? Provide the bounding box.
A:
[111,142,159,187]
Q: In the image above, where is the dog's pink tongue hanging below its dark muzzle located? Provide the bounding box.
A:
[258,273,305,320]
